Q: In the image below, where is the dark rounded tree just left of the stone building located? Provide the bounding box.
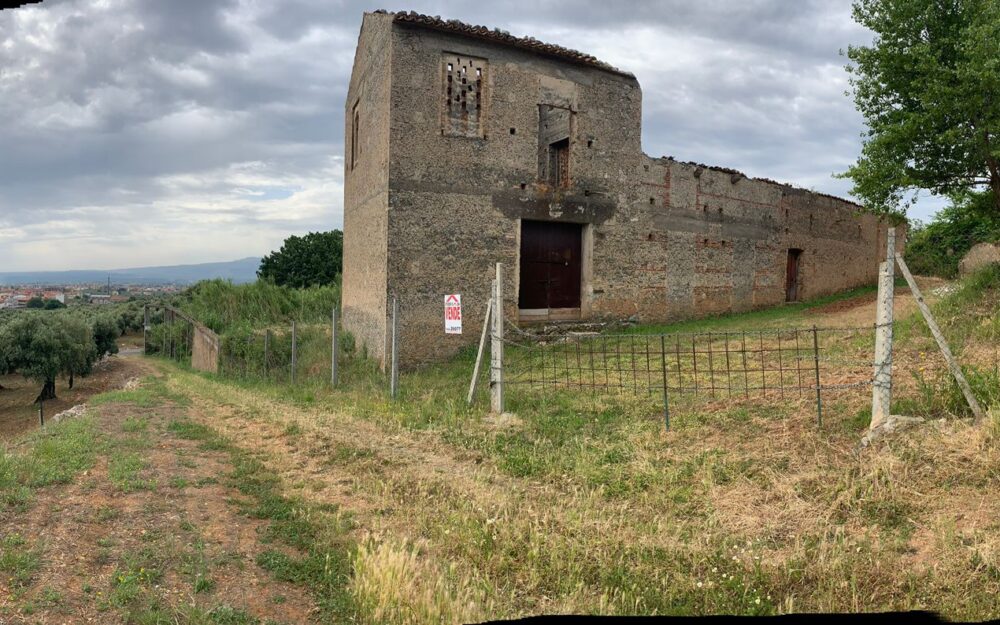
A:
[257,230,344,288]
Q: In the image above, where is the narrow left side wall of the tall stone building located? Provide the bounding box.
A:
[342,13,392,364]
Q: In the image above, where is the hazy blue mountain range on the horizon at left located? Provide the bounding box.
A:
[0,257,260,286]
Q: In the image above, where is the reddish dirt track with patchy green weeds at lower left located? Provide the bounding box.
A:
[0,361,315,623]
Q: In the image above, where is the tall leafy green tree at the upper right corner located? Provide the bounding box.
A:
[842,0,1000,215]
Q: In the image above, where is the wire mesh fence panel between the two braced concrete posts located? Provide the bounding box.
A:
[503,322,873,424]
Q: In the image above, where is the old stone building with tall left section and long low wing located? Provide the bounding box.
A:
[343,12,902,365]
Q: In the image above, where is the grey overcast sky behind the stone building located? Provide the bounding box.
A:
[0,0,938,271]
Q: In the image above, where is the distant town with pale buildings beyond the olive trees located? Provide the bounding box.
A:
[0,283,178,310]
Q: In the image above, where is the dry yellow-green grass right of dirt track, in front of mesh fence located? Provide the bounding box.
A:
[161,352,1000,623]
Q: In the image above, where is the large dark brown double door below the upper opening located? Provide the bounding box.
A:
[518,221,583,309]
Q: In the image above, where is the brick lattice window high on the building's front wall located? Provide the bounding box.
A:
[441,54,486,138]
